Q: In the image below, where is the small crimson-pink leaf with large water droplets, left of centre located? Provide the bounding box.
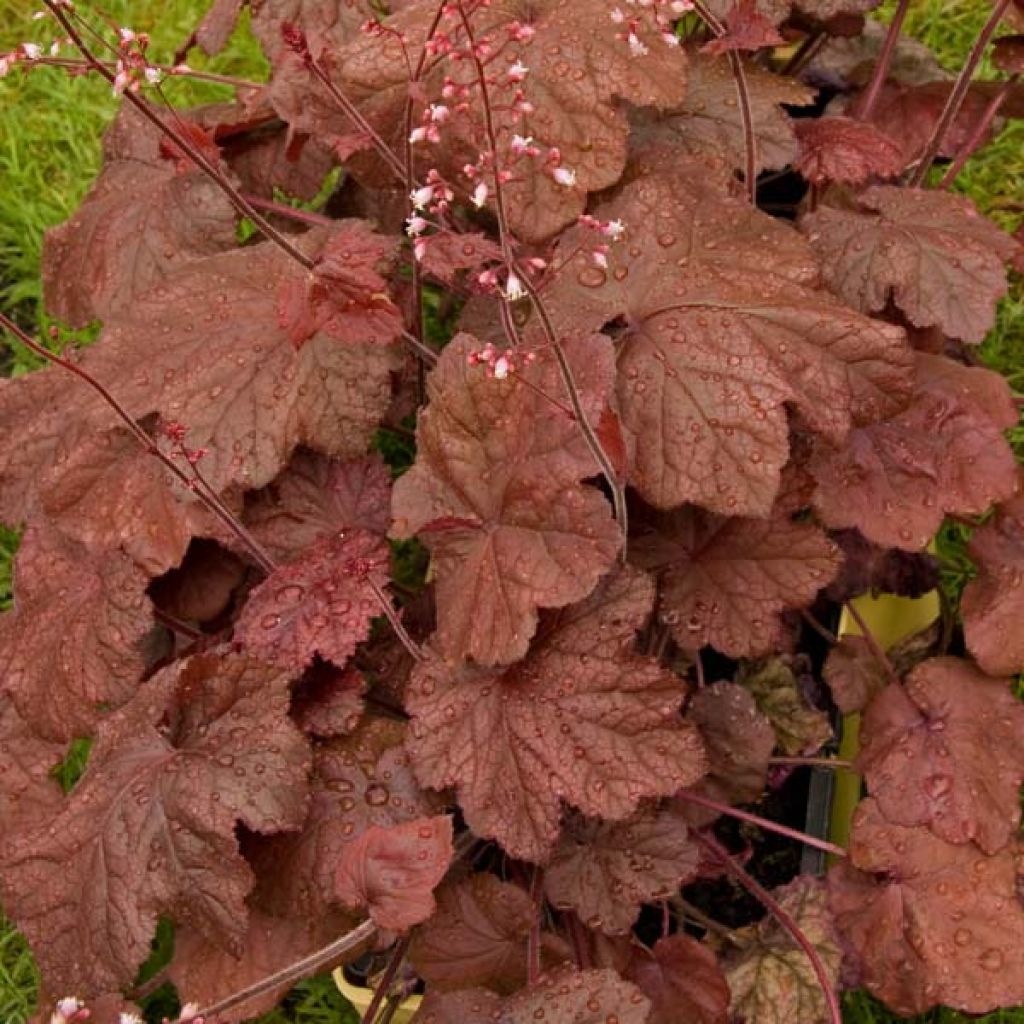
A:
[234,529,388,669]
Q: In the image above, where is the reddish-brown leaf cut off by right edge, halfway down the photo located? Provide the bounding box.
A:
[961,497,1024,676]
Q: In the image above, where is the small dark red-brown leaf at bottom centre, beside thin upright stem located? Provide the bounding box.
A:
[409,874,552,995]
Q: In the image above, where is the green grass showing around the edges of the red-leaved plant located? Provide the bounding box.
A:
[0,0,1024,1024]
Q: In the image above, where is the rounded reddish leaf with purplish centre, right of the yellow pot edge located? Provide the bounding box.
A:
[857,657,1024,853]
